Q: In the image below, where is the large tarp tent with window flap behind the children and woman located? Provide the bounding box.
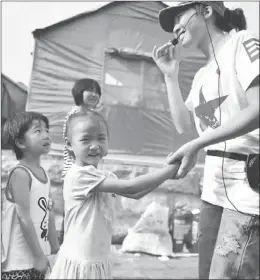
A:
[27,1,205,162]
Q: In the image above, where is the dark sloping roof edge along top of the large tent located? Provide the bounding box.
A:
[32,1,168,38]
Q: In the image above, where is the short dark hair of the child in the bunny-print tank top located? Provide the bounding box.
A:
[2,112,49,159]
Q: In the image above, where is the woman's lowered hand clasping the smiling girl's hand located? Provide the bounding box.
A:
[166,140,200,179]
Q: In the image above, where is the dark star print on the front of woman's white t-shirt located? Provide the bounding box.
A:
[195,87,228,131]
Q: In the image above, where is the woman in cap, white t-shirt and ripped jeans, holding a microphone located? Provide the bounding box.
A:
[153,1,259,279]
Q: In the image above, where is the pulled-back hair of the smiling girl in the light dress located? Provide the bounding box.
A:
[67,110,109,144]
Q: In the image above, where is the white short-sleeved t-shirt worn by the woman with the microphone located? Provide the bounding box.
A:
[185,31,259,215]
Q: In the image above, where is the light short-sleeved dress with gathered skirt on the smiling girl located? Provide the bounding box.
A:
[49,164,116,279]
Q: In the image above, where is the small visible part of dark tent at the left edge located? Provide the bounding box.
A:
[1,74,27,123]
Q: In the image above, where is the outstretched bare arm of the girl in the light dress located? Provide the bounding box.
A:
[94,163,179,199]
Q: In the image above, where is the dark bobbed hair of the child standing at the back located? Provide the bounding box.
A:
[72,78,101,106]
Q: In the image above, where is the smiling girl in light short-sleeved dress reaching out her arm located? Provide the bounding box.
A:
[47,111,179,279]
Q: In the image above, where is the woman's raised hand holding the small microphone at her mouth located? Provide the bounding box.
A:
[152,44,180,76]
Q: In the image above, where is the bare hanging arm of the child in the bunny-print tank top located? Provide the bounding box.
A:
[10,168,45,259]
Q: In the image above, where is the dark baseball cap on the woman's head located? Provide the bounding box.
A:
[159,1,226,33]
